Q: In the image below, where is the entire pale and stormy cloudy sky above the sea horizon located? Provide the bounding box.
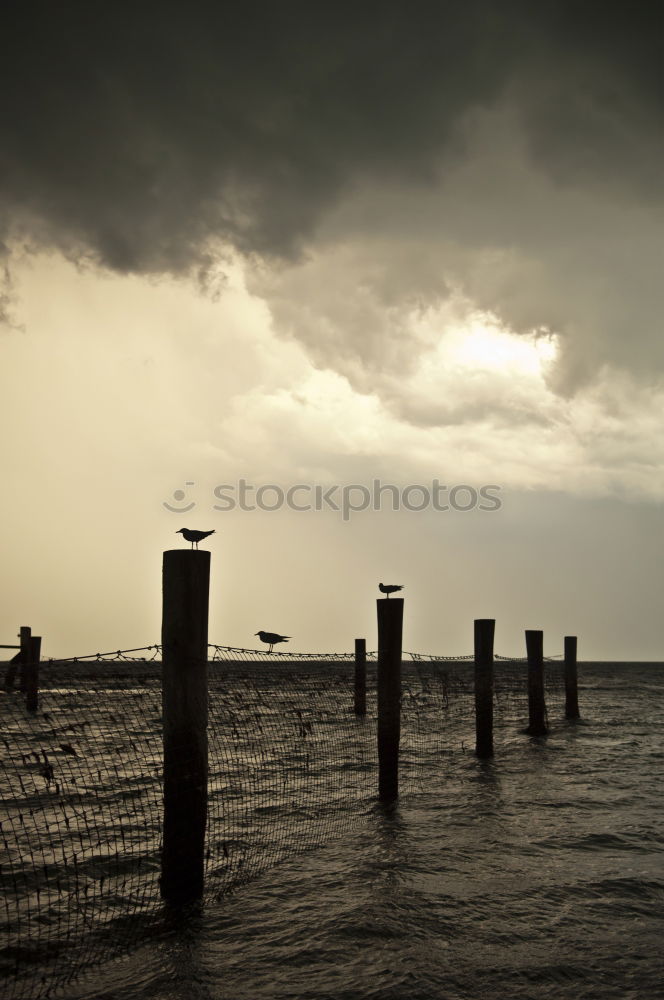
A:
[0,0,664,659]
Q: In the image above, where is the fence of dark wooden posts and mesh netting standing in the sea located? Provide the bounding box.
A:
[0,549,578,1000]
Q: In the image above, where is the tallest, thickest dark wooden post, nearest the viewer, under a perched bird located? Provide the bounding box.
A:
[160,549,210,905]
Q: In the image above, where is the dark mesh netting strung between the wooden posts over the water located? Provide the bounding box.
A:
[0,646,563,1000]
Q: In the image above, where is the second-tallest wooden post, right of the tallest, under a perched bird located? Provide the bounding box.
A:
[376,597,403,802]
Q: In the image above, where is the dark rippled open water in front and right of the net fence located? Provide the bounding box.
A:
[54,664,664,1000]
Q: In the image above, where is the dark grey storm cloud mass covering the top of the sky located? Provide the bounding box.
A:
[0,0,664,387]
